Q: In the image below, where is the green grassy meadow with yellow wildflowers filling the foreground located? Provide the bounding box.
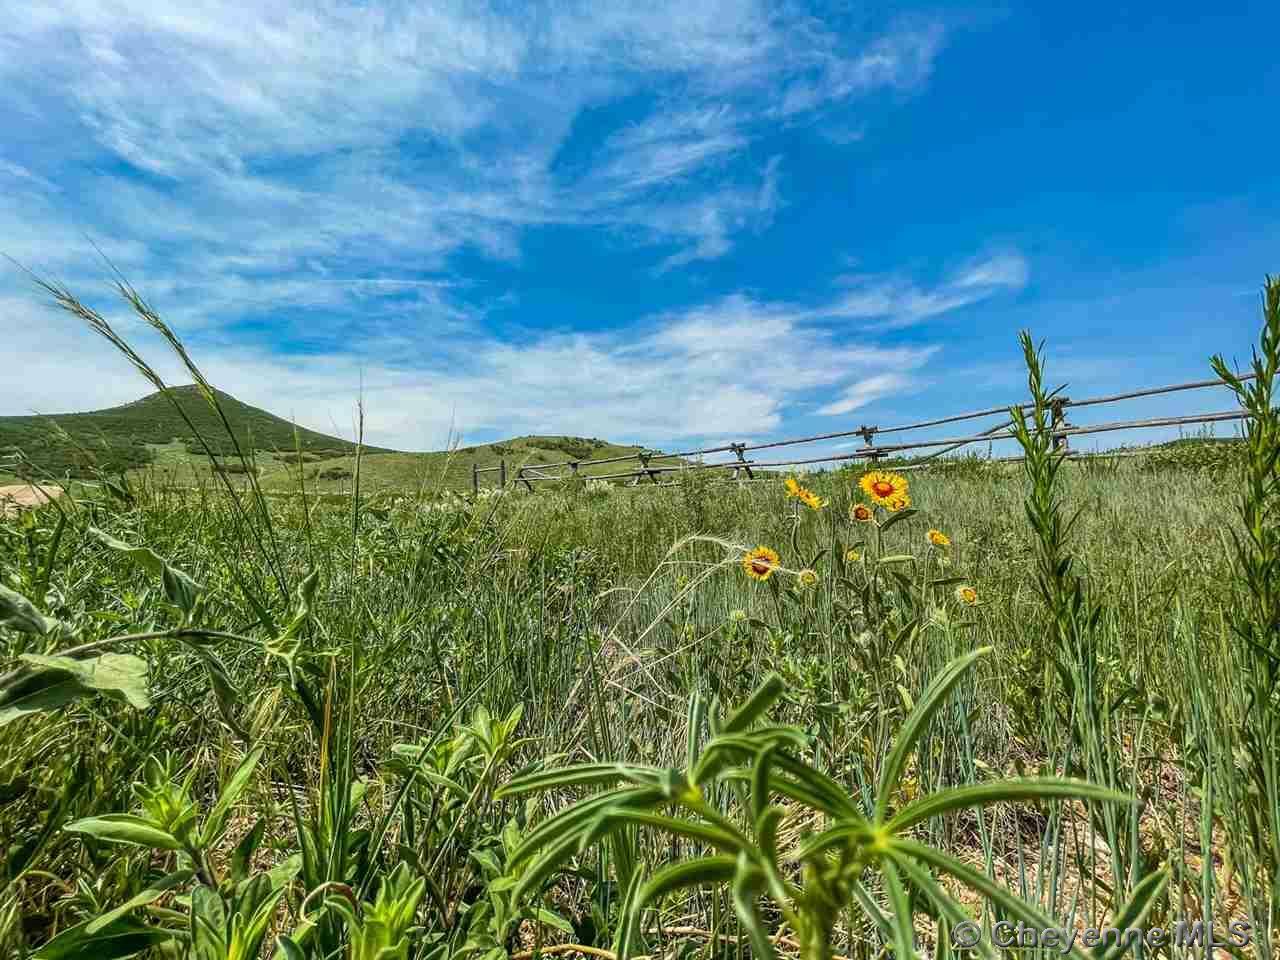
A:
[0,273,1280,960]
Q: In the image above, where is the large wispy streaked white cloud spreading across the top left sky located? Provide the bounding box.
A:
[0,0,942,285]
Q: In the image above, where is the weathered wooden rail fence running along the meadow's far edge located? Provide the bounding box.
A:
[471,374,1253,493]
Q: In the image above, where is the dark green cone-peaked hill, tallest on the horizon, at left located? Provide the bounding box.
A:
[0,385,389,476]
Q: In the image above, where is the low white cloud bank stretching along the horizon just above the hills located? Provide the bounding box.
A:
[0,284,934,449]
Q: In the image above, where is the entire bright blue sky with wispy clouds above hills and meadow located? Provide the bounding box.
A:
[0,0,1280,458]
